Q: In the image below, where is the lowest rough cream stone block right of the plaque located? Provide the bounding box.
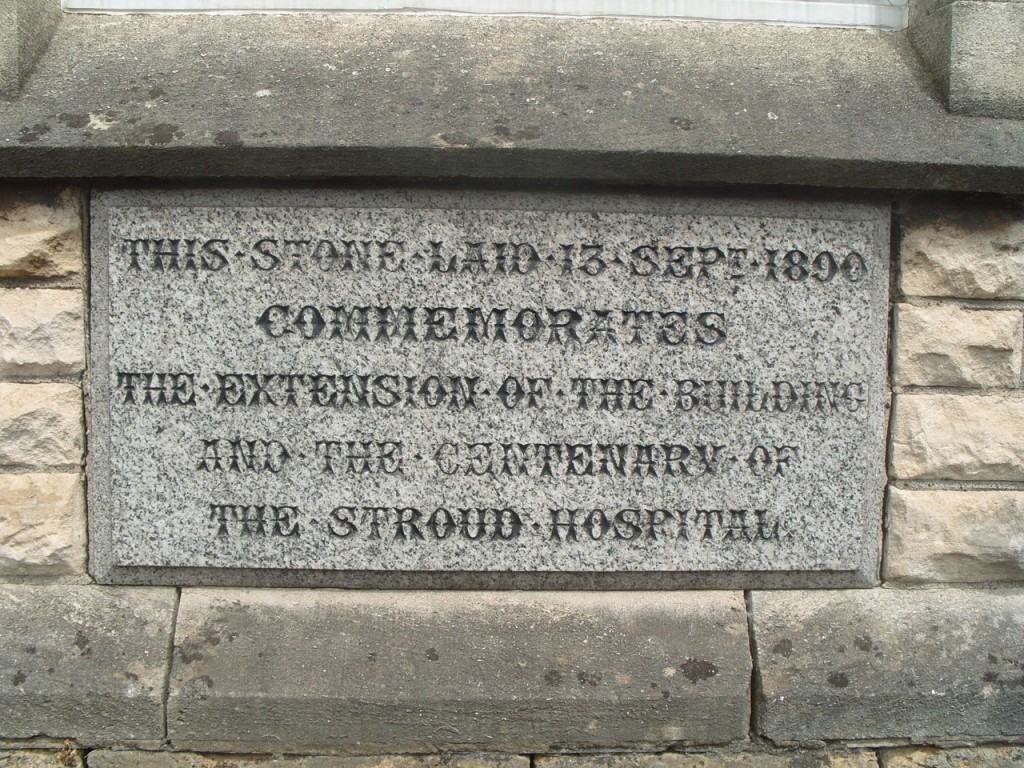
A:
[885,488,1024,582]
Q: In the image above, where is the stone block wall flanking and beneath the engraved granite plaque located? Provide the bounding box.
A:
[0,185,1024,768]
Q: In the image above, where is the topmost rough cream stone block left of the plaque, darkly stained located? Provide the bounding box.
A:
[0,187,82,278]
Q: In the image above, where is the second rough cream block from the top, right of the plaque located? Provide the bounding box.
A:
[895,304,1022,387]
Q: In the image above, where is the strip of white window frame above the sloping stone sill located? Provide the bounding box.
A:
[62,0,907,30]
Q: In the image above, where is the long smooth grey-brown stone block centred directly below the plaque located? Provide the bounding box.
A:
[168,590,751,754]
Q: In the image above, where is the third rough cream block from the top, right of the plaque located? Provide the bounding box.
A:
[892,394,1024,480]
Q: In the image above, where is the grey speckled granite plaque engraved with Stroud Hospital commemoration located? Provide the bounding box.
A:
[90,189,889,588]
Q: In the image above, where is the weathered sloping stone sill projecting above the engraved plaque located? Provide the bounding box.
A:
[6,14,1024,194]
